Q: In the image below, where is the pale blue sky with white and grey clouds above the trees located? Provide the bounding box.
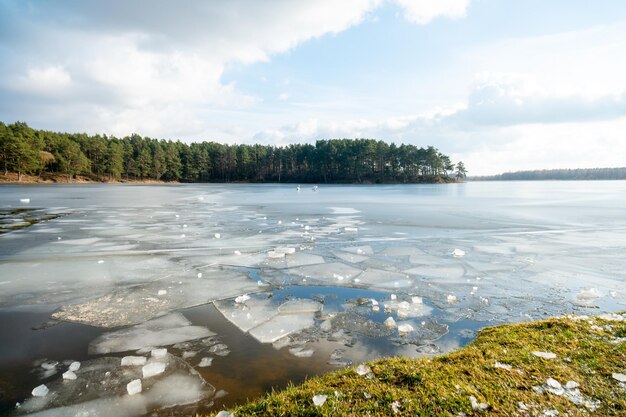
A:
[0,0,626,175]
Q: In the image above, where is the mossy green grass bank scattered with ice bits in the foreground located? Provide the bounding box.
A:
[207,313,626,417]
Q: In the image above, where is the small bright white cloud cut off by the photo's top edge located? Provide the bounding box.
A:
[393,0,470,25]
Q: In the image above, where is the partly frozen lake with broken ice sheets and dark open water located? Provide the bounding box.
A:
[0,181,626,416]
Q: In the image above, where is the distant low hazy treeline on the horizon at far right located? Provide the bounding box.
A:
[470,167,626,181]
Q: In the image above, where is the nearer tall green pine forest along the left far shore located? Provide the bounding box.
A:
[0,122,466,183]
